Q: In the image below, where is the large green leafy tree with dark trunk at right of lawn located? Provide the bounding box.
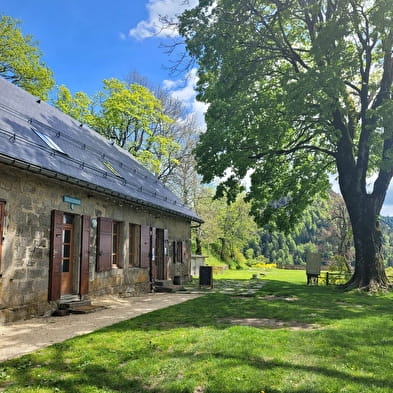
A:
[179,0,393,289]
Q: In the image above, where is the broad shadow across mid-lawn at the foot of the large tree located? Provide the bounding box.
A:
[102,281,393,331]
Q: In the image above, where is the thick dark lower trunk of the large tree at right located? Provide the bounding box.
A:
[343,195,389,291]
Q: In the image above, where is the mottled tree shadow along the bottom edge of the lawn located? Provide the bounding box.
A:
[0,334,393,393]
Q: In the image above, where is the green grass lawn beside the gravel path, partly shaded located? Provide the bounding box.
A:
[0,270,393,393]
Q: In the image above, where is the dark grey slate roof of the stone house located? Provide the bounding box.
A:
[0,77,202,222]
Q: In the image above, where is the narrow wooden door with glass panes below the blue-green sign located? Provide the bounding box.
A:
[60,214,74,295]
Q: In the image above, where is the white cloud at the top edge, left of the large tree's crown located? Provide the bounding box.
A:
[129,0,198,40]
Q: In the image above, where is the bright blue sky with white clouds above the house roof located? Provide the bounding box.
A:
[0,0,204,116]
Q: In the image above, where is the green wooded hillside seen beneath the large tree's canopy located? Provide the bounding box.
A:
[196,192,393,267]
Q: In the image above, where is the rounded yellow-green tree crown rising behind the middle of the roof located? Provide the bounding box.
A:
[91,78,180,174]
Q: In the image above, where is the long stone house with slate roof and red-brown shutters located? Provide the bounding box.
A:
[0,78,201,323]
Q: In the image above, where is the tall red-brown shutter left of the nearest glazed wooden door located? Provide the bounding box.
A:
[48,210,63,300]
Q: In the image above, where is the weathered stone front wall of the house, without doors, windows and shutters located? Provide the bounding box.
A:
[0,164,190,322]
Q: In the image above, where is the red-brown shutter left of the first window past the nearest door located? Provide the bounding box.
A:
[96,217,112,272]
